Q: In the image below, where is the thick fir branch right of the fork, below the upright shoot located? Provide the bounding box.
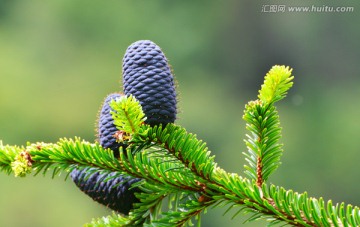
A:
[208,169,360,227]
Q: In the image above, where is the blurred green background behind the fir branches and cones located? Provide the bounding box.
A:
[0,0,360,227]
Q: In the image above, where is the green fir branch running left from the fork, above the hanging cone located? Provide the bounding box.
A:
[27,138,201,195]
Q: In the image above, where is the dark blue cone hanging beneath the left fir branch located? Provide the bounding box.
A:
[71,168,141,215]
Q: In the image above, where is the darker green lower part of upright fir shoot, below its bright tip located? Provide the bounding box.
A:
[243,100,282,187]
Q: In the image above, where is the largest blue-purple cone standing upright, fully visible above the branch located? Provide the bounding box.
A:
[123,40,177,126]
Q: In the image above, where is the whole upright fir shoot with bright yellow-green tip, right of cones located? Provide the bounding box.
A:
[243,65,294,187]
